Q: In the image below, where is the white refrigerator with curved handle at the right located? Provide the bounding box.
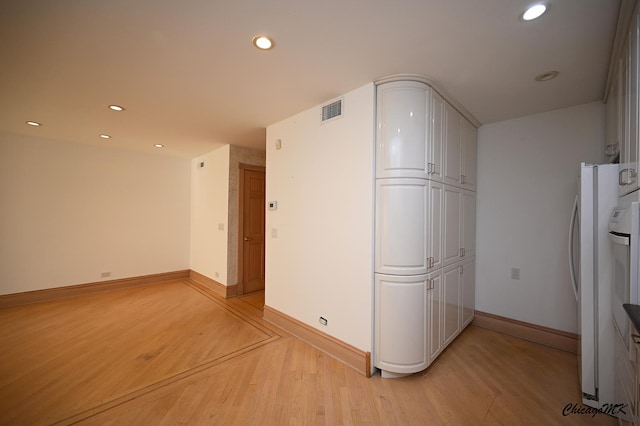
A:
[569,163,618,408]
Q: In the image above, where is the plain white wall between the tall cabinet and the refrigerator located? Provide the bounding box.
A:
[476,102,604,333]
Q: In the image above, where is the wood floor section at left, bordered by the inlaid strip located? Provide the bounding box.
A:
[0,282,273,424]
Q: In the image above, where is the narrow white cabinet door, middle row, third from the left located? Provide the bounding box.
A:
[442,185,462,266]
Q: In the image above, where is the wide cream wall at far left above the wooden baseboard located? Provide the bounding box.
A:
[0,134,190,294]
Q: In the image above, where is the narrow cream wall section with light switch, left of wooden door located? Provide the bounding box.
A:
[187,145,235,285]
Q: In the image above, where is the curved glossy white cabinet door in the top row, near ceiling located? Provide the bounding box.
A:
[376,81,431,179]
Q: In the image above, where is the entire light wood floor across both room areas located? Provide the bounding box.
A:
[0,281,616,425]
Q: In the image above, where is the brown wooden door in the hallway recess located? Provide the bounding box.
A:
[241,168,265,293]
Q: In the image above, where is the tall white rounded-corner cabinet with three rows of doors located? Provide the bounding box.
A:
[374,80,476,377]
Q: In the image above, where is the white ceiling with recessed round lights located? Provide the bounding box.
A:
[0,0,620,158]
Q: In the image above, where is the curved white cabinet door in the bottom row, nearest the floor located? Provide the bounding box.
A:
[374,274,429,374]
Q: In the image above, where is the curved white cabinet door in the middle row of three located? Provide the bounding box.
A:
[375,179,429,275]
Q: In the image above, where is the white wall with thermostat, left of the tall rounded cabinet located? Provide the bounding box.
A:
[265,83,375,351]
